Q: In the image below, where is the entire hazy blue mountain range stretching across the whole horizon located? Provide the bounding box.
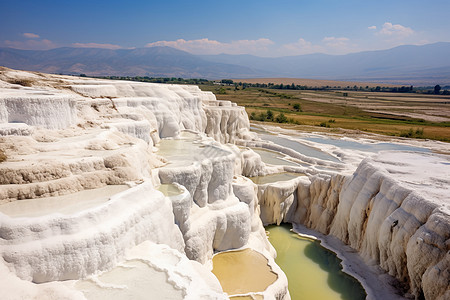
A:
[0,43,450,85]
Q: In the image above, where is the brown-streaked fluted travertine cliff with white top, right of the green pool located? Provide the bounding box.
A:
[268,152,450,299]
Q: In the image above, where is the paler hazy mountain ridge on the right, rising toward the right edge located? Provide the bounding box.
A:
[202,43,450,84]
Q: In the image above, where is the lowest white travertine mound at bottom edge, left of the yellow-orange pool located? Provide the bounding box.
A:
[73,241,227,300]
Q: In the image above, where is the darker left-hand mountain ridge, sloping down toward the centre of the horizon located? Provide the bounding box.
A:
[0,47,260,78]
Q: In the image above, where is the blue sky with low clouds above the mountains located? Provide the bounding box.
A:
[0,0,450,56]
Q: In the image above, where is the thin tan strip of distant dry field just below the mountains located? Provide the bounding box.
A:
[233,78,401,88]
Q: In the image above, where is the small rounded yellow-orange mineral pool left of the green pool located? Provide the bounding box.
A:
[212,249,278,299]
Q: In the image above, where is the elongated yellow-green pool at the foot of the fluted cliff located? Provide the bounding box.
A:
[266,224,366,300]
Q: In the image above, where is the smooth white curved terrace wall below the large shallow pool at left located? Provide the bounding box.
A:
[0,182,184,283]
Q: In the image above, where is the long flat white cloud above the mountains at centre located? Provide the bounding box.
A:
[146,38,274,55]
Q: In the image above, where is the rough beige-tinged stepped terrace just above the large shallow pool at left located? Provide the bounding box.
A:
[0,128,162,204]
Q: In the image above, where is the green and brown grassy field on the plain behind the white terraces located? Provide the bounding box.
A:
[199,84,450,142]
